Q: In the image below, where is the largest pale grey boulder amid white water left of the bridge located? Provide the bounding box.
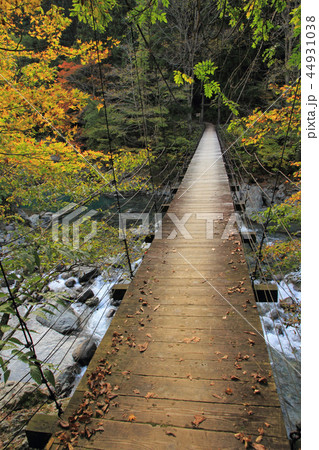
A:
[37,293,81,334]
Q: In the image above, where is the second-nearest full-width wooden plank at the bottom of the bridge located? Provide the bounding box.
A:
[58,392,283,437]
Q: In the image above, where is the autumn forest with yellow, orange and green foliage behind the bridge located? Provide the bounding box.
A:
[0,0,302,382]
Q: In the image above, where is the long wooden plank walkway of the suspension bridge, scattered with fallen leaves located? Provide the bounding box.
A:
[47,126,289,450]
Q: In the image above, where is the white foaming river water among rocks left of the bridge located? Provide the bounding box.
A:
[2,248,149,382]
